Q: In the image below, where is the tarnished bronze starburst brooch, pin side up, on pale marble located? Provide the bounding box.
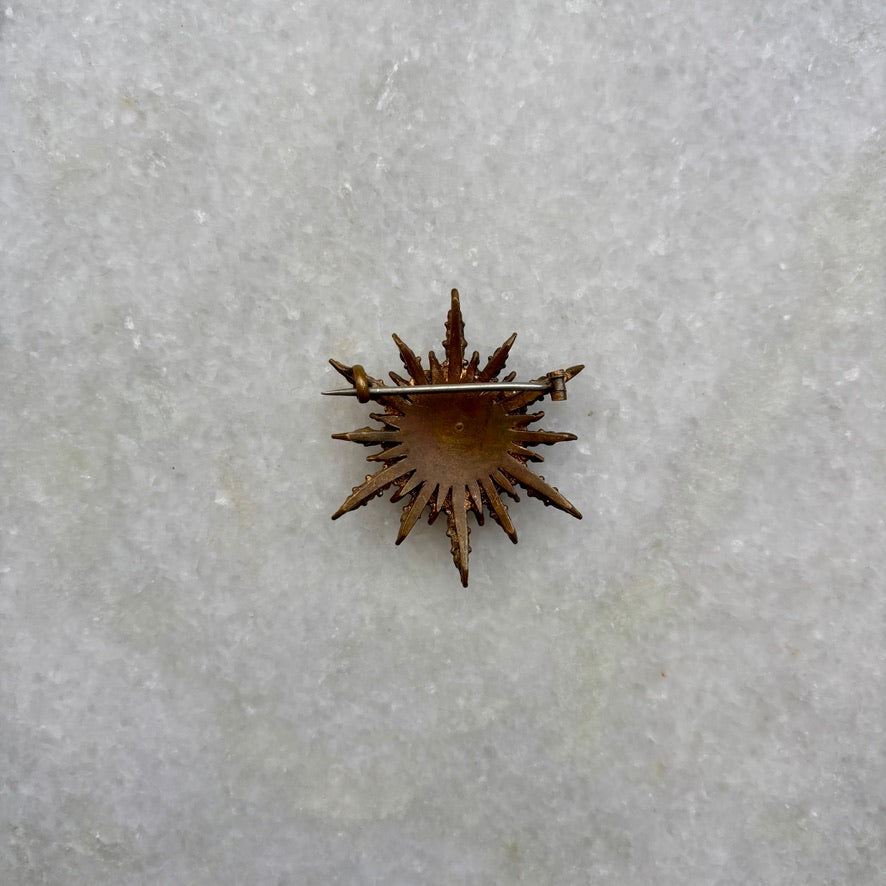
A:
[326,289,584,587]
